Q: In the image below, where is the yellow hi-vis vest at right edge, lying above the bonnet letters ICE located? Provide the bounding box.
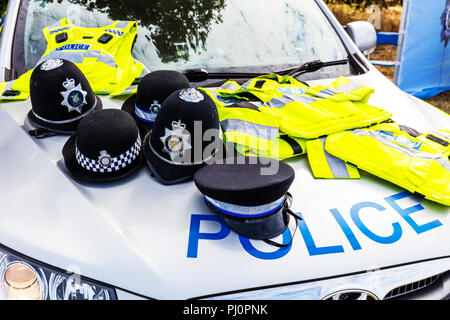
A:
[325,123,450,206]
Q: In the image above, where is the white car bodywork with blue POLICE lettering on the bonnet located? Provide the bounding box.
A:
[0,1,450,299]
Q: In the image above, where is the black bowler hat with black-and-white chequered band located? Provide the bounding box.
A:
[63,109,142,183]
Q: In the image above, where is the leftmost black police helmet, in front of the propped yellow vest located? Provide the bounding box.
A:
[28,59,102,135]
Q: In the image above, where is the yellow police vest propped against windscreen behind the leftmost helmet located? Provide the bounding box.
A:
[0,18,144,100]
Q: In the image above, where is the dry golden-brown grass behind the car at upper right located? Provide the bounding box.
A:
[330,5,450,114]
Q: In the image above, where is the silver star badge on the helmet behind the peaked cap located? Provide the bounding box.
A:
[160,121,192,161]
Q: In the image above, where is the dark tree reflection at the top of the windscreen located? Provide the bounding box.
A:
[39,0,225,63]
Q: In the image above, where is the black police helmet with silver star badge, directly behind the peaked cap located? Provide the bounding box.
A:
[143,88,221,184]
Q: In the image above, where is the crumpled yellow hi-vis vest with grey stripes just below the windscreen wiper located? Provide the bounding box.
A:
[216,75,392,139]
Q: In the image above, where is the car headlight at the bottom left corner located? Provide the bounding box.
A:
[0,248,117,300]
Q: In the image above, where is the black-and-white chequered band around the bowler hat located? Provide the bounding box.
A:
[75,136,141,173]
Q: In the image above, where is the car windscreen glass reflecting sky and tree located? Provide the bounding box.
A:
[14,0,350,76]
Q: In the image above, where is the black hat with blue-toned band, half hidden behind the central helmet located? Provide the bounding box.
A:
[122,70,189,136]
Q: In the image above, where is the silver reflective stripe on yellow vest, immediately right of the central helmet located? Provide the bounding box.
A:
[220,119,278,140]
